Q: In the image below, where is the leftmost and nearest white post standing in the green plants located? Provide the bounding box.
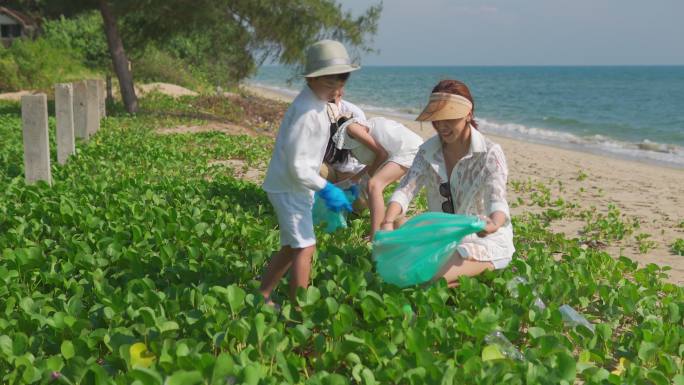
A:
[21,94,52,184]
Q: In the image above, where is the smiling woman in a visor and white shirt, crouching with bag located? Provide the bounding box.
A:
[382,80,515,287]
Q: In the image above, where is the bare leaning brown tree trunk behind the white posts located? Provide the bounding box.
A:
[99,0,138,114]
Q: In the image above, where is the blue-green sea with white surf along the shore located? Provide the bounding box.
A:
[248,66,684,169]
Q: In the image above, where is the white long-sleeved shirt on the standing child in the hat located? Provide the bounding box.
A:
[262,86,331,193]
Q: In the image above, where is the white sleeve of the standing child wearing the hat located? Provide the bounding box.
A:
[283,112,329,191]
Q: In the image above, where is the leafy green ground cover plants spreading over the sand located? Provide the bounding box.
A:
[0,96,684,384]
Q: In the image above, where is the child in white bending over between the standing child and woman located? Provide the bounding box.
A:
[325,117,423,239]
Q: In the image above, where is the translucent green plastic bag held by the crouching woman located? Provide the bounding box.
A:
[373,212,485,287]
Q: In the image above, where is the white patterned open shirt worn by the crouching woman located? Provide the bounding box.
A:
[390,128,515,259]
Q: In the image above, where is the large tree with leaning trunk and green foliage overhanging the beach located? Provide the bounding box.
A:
[14,0,382,113]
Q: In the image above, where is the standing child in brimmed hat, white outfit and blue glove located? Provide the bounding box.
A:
[259,40,360,305]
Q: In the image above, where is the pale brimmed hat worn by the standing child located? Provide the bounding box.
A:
[304,40,361,78]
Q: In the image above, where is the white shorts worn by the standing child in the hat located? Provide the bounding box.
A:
[267,191,316,249]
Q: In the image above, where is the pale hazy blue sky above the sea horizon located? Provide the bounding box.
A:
[339,0,684,65]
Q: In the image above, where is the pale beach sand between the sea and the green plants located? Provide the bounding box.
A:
[243,85,684,285]
